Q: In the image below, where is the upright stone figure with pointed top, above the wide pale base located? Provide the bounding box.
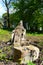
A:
[12,20,26,46]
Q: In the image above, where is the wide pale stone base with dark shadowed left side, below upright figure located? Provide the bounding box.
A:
[14,45,39,63]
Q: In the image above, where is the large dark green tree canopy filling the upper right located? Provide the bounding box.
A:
[12,0,43,32]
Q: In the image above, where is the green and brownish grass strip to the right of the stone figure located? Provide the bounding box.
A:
[26,33,43,43]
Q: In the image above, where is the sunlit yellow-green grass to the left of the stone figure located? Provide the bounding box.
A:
[0,29,11,41]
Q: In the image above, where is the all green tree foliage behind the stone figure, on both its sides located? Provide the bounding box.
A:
[3,0,43,32]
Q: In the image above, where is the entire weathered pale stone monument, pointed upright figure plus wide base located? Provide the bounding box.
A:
[12,20,39,63]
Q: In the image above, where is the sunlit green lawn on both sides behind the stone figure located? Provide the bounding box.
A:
[0,29,43,41]
